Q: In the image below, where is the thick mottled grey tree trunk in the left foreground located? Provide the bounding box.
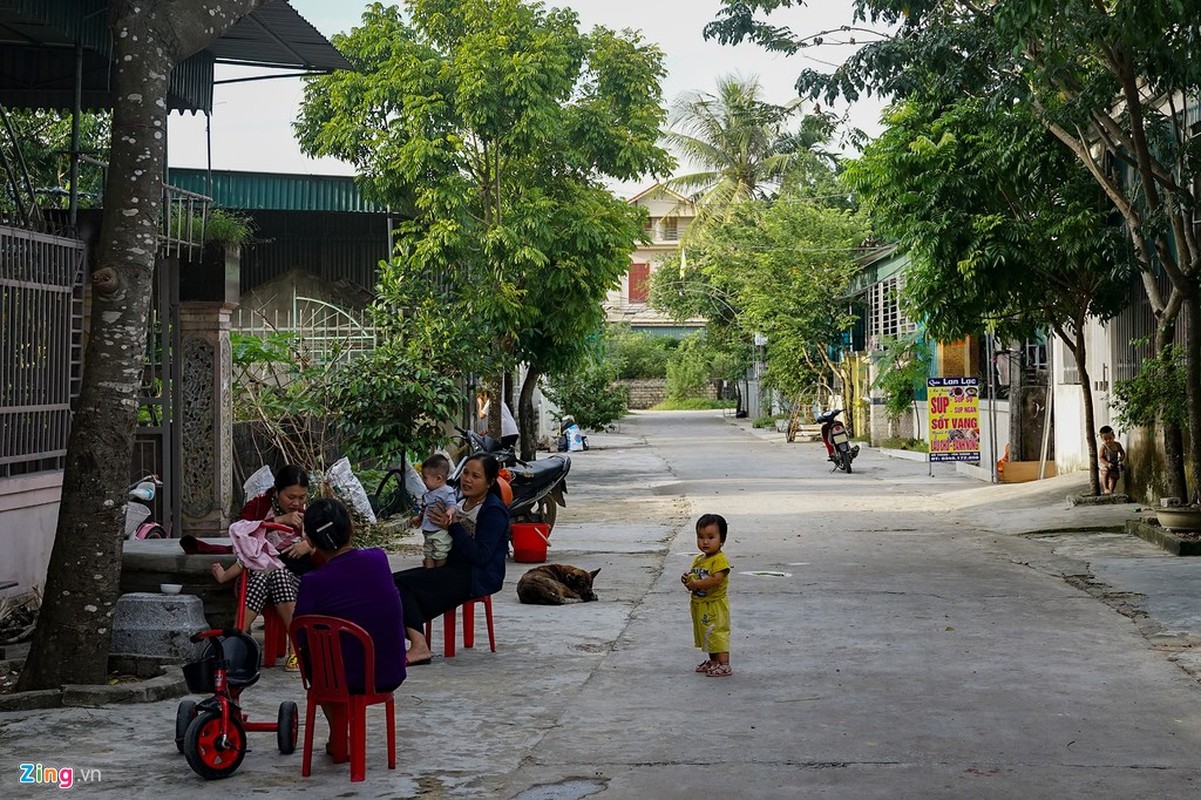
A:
[17,0,270,691]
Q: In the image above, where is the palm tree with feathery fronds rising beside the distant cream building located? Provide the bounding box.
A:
[663,76,832,216]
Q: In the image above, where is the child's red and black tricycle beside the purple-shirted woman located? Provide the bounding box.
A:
[175,523,300,781]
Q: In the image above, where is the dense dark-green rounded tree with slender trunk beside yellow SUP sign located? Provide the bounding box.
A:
[843,97,1136,494]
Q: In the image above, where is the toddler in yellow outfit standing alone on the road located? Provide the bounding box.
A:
[680,514,733,677]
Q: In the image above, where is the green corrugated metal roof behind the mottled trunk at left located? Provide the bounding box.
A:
[167,167,386,214]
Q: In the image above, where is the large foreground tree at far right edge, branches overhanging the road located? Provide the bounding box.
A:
[706,0,1201,496]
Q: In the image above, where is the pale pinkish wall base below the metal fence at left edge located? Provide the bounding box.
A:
[0,472,62,596]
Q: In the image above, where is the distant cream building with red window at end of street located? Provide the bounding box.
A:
[604,184,705,336]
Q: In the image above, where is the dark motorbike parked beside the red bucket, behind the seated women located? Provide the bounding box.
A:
[448,428,572,529]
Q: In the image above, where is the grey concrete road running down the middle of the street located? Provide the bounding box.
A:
[0,412,1201,800]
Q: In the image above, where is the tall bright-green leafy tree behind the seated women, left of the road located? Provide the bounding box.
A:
[297,0,670,456]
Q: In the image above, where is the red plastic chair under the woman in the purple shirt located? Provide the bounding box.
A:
[291,614,396,781]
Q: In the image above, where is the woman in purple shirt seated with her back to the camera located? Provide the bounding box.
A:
[293,498,405,692]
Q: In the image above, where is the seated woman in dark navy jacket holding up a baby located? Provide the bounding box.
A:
[393,453,509,667]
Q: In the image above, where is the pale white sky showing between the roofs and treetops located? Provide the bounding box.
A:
[168,0,883,189]
